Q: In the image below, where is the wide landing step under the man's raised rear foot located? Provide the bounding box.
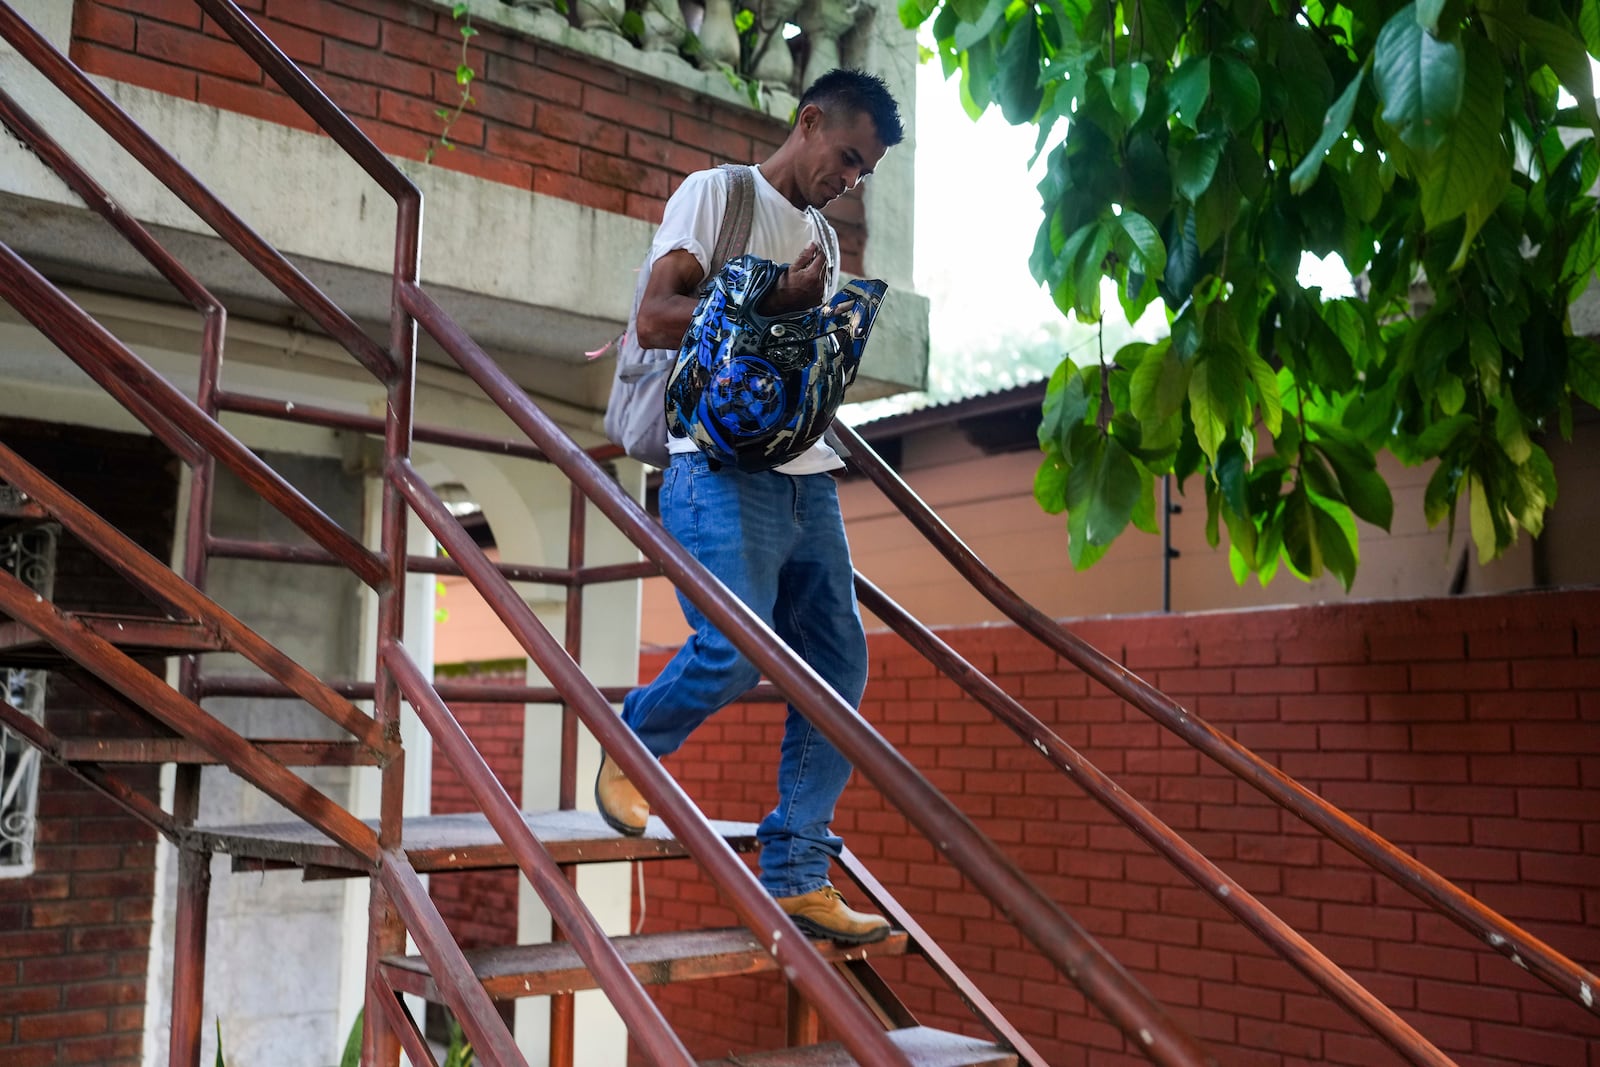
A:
[189,811,757,873]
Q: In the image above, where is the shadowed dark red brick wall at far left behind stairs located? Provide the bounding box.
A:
[0,419,178,1067]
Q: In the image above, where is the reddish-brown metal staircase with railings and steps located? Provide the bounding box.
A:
[0,0,1597,1067]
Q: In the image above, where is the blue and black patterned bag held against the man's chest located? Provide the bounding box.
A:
[667,256,888,472]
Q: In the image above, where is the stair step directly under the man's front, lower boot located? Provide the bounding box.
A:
[382,926,907,1000]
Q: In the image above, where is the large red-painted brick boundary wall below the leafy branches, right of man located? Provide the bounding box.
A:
[624,590,1600,1067]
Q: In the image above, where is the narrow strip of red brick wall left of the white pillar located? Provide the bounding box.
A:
[429,670,526,949]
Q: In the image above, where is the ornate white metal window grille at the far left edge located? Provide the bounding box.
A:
[0,485,56,878]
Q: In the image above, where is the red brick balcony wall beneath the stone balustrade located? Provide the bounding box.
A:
[72,0,866,272]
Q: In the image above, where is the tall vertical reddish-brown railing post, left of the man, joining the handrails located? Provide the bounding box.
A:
[362,190,422,1067]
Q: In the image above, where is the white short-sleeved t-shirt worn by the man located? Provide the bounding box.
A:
[640,166,845,474]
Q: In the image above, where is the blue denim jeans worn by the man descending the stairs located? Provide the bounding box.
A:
[622,453,867,896]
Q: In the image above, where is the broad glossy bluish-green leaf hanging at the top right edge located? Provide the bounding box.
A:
[1373,5,1467,165]
